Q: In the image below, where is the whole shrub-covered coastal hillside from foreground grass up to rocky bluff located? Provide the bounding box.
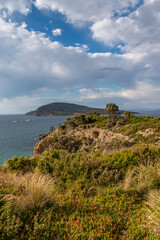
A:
[0,114,160,240]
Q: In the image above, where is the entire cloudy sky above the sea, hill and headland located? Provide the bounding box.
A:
[0,0,160,114]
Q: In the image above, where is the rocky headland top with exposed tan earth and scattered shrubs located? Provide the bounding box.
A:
[33,113,160,156]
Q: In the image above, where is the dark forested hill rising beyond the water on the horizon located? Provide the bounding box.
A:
[26,102,106,116]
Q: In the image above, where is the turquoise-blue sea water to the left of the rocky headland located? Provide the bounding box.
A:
[0,115,66,165]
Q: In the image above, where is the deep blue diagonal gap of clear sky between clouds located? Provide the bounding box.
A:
[11,5,106,52]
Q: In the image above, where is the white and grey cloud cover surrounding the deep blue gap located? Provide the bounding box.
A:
[0,0,160,111]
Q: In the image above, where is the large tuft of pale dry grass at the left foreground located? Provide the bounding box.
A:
[0,170,55,210]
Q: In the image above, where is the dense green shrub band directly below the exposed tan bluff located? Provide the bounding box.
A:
[35,147,160,188]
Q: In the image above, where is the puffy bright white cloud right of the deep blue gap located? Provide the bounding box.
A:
[91,0,160,48]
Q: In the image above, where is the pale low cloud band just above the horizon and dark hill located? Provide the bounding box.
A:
[0,80,160,114]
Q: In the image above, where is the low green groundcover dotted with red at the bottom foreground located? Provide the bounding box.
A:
[10,188,155,240]
